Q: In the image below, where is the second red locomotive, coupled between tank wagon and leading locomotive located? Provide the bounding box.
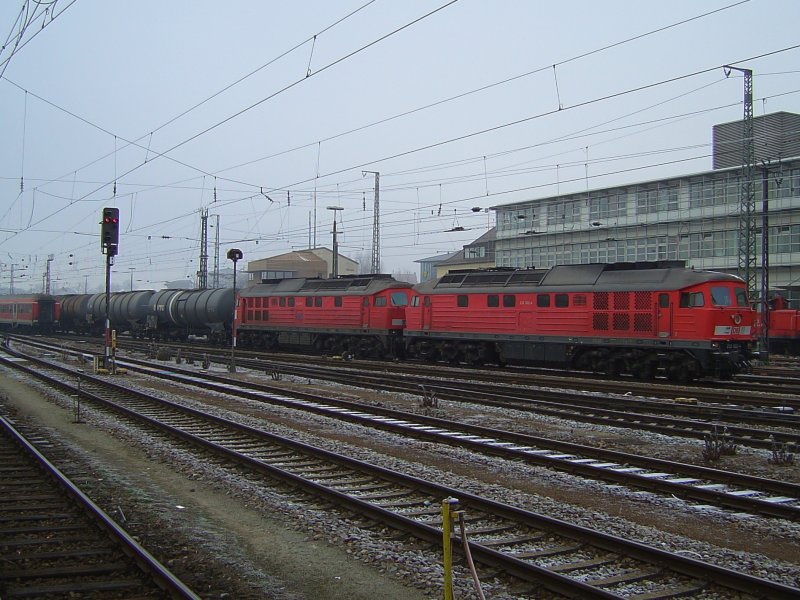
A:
[236,275,411,358]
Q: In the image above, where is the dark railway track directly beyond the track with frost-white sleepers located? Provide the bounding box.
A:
[28,338,800,452]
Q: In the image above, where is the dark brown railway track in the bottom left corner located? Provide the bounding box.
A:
[0,416,199,600]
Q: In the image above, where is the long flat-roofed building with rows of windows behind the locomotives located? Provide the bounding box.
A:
[492,113,800,301]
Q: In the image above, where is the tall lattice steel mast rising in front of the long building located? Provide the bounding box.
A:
[723,66,766,302]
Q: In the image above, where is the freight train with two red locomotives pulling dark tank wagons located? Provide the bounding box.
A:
[0,262,756,381]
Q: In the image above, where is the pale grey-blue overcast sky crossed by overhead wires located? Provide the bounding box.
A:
[0,0,800,292]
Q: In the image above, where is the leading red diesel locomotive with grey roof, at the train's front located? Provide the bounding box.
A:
[404,262,755,381]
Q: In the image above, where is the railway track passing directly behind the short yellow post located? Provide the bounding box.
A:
[1,346,800,600]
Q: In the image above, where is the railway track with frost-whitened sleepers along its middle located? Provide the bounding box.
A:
[6,338,800,521]
